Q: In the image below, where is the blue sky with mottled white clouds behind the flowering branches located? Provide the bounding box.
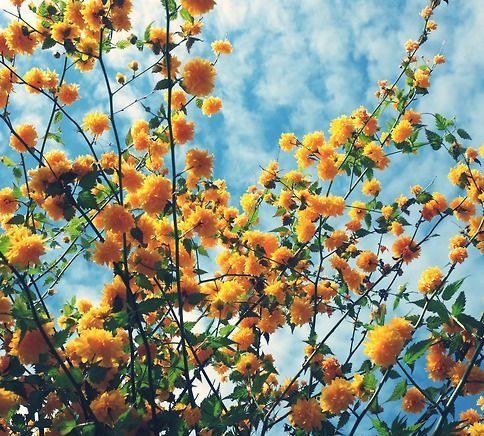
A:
[0,0,484,434]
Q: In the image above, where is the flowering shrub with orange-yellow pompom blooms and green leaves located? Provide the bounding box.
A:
[0,0,484,435]
